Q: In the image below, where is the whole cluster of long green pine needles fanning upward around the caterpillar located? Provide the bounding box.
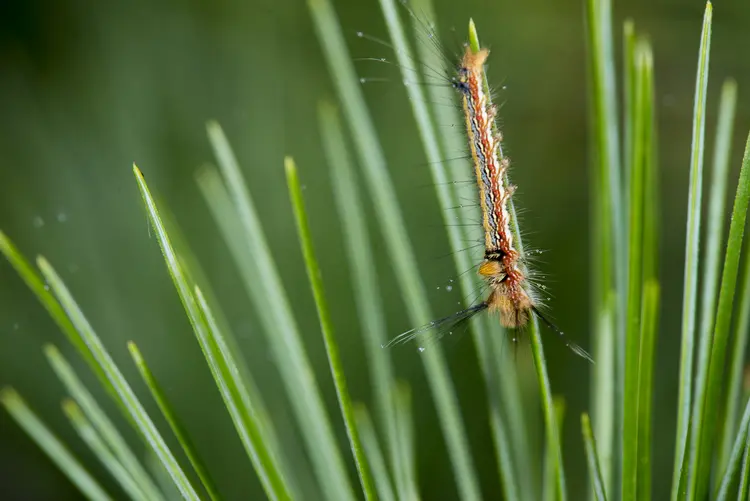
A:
[0,0,750,501]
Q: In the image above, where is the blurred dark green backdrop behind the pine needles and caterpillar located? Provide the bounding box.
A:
[0,0,750,500]
